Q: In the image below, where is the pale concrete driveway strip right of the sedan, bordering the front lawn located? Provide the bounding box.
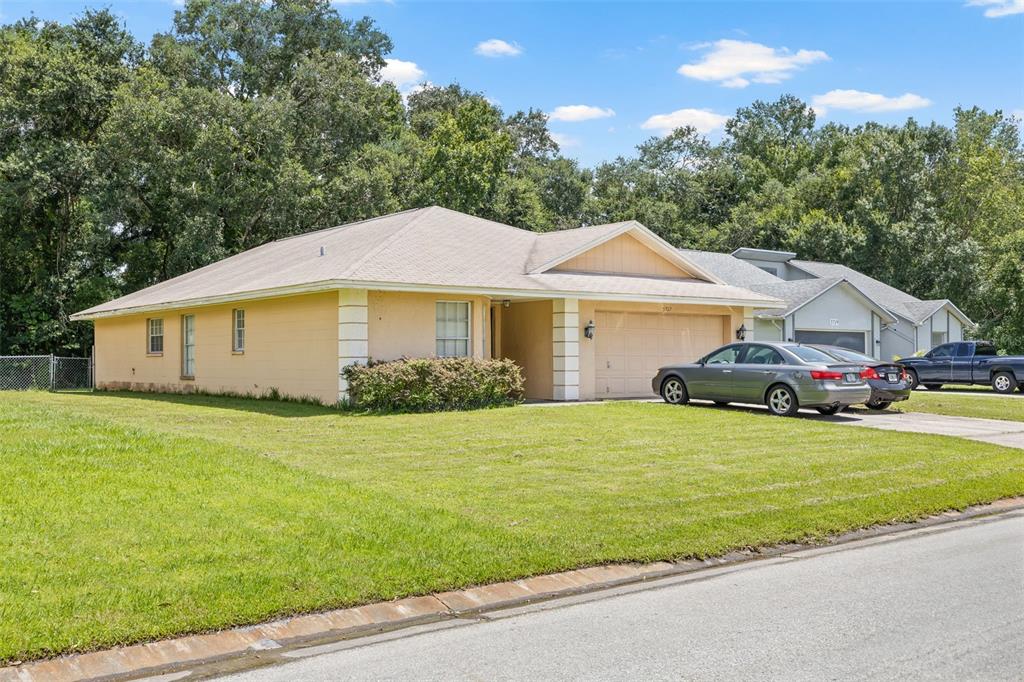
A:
[812,411,1024,450]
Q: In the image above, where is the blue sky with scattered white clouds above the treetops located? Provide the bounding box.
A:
[0,0,1024,165]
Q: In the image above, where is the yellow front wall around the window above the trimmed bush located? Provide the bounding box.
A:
[367,291,490,360]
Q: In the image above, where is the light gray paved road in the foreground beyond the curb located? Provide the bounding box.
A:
[224,512,1024,682]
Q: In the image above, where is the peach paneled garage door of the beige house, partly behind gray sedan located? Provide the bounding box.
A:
[594,310,725,398]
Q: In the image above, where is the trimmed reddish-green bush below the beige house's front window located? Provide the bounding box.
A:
[344,357,523,412]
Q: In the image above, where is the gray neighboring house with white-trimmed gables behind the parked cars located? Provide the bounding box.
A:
[683,249,974,359]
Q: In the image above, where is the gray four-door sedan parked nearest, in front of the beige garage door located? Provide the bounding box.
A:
[651,343,871,417]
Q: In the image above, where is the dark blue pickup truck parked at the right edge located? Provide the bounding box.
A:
[897,341,1024,393]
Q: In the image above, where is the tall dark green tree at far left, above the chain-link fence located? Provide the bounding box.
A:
[0,10,142,353]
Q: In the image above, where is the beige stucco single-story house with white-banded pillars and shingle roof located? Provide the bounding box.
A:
[73,207,783,403]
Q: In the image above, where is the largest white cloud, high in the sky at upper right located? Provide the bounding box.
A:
[678,39,829,88]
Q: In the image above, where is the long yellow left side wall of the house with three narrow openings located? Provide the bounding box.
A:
[95,292,338,404]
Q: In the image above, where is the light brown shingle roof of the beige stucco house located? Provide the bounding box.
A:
[74,207,775,319]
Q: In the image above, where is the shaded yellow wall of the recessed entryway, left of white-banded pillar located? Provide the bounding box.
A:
[501,301,554,400]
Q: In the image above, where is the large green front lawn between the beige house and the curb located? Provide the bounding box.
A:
[0,392,1024,662]
